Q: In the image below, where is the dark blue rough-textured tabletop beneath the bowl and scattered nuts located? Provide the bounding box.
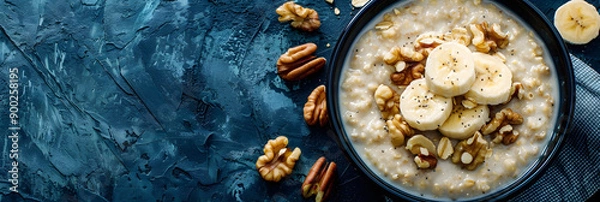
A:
[0,0,600,201]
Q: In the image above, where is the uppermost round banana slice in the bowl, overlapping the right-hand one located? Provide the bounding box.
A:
[425,42,475,97]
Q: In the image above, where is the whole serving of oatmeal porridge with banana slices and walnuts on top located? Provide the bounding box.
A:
[339,0,558,199]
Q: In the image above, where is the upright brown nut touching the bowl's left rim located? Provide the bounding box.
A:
[304,85,329,126]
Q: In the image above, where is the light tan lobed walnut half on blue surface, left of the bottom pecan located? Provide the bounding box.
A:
[256,136,301,182]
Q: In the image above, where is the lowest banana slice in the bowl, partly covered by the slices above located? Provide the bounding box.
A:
[438,103,490,140]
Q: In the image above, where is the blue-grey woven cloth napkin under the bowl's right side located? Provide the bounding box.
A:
[512,55,600,201]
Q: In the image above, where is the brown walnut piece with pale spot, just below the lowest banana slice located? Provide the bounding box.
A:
[452,131,489,170]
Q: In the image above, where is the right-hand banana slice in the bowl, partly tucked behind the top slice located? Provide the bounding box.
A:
[465,53,512,105]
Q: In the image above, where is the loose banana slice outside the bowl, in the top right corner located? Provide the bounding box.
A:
[554,0,600,44]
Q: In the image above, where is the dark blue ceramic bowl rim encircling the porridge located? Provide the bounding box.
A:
[327,0,575,201]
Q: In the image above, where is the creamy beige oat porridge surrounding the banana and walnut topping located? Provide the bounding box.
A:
[340,0,558,199]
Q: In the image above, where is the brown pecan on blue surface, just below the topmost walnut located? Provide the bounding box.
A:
[277,43,326,81]
